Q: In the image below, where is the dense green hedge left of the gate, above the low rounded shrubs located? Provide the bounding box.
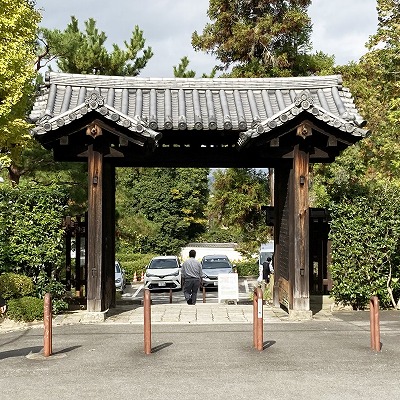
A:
[0,185,67,278]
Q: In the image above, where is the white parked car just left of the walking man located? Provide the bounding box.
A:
[144,256,182,289]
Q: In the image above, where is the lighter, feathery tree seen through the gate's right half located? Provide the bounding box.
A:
[207,168,271,254]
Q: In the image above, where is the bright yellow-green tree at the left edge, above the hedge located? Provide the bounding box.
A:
[0,0,40,175]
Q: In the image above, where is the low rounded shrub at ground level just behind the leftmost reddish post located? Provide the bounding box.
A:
[7,296,44,322]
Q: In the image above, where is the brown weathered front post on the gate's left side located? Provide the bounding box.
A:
[86,144,104,312]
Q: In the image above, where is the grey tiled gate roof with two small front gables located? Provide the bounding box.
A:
[30,72,367,145]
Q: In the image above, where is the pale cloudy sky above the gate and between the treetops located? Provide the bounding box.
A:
[36,0,377,78]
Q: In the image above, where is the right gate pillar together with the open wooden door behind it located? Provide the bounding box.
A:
[273,145,311,318]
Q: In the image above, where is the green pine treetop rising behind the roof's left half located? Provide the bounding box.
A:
[39,16,153,76]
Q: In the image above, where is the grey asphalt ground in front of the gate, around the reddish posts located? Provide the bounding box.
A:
[0,304,400,400]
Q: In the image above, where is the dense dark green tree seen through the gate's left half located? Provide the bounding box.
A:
[116,168,208,254]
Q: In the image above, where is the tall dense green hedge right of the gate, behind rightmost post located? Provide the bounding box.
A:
[330,183,400,309]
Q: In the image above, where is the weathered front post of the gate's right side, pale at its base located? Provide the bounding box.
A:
[291,145,310,311]
